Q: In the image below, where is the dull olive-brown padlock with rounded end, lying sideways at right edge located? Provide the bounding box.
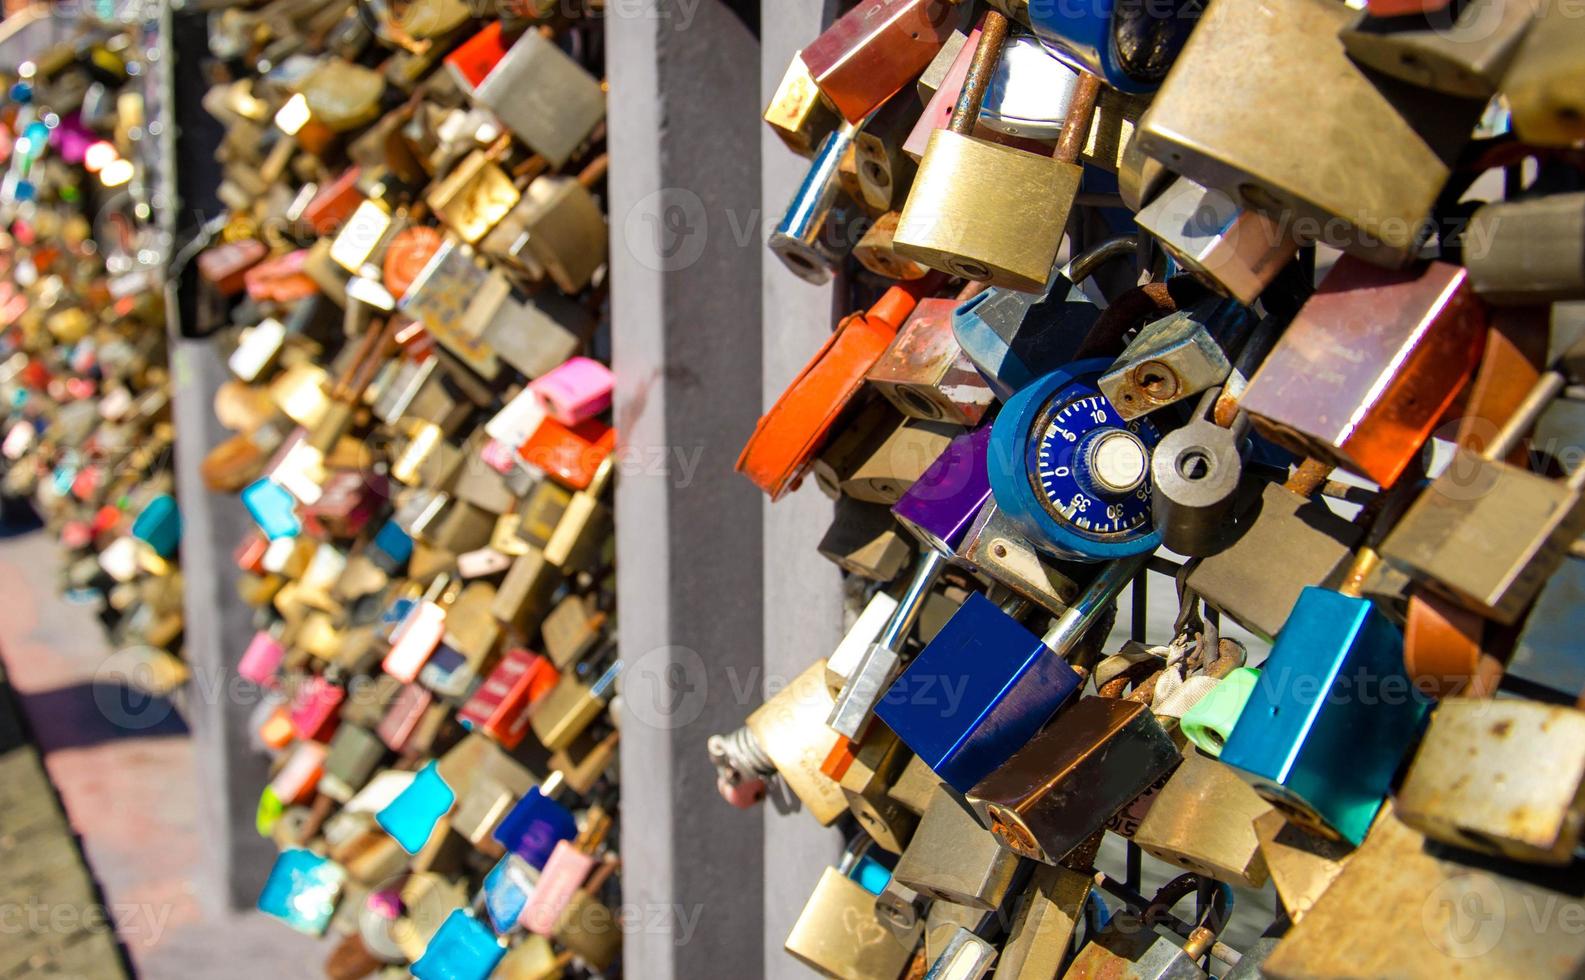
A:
[1463,193,1585,306]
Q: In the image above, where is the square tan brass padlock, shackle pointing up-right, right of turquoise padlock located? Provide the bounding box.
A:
[1381,363,1585,623]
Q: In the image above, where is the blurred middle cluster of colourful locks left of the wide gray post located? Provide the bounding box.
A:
[197,0,621,978]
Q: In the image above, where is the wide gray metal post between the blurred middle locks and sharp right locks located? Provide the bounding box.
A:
[605,0,764,980]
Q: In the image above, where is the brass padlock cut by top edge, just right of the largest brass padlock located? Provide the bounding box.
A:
[1338,0,1536,100]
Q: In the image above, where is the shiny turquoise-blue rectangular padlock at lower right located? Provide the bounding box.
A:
[1222,585,1430,844]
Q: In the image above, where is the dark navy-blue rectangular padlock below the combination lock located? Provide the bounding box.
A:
[875,593,1083,793]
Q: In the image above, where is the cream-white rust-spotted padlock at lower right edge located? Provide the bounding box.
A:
[1393,698,1585,864]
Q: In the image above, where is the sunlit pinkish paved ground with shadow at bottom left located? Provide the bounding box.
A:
[0,531,327,980]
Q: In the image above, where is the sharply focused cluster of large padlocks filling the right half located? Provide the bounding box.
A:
[708,0,1585,980]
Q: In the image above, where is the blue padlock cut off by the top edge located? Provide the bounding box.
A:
[1029,0,1203,92]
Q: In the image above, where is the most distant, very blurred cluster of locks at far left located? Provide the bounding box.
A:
[0,24,187,698]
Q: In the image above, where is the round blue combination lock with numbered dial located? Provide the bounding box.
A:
[989,358,1162,561]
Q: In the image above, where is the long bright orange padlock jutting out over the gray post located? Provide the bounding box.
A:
[737,274,941,500]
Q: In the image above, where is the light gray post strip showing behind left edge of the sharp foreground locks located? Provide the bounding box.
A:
[754,0,842,980]
